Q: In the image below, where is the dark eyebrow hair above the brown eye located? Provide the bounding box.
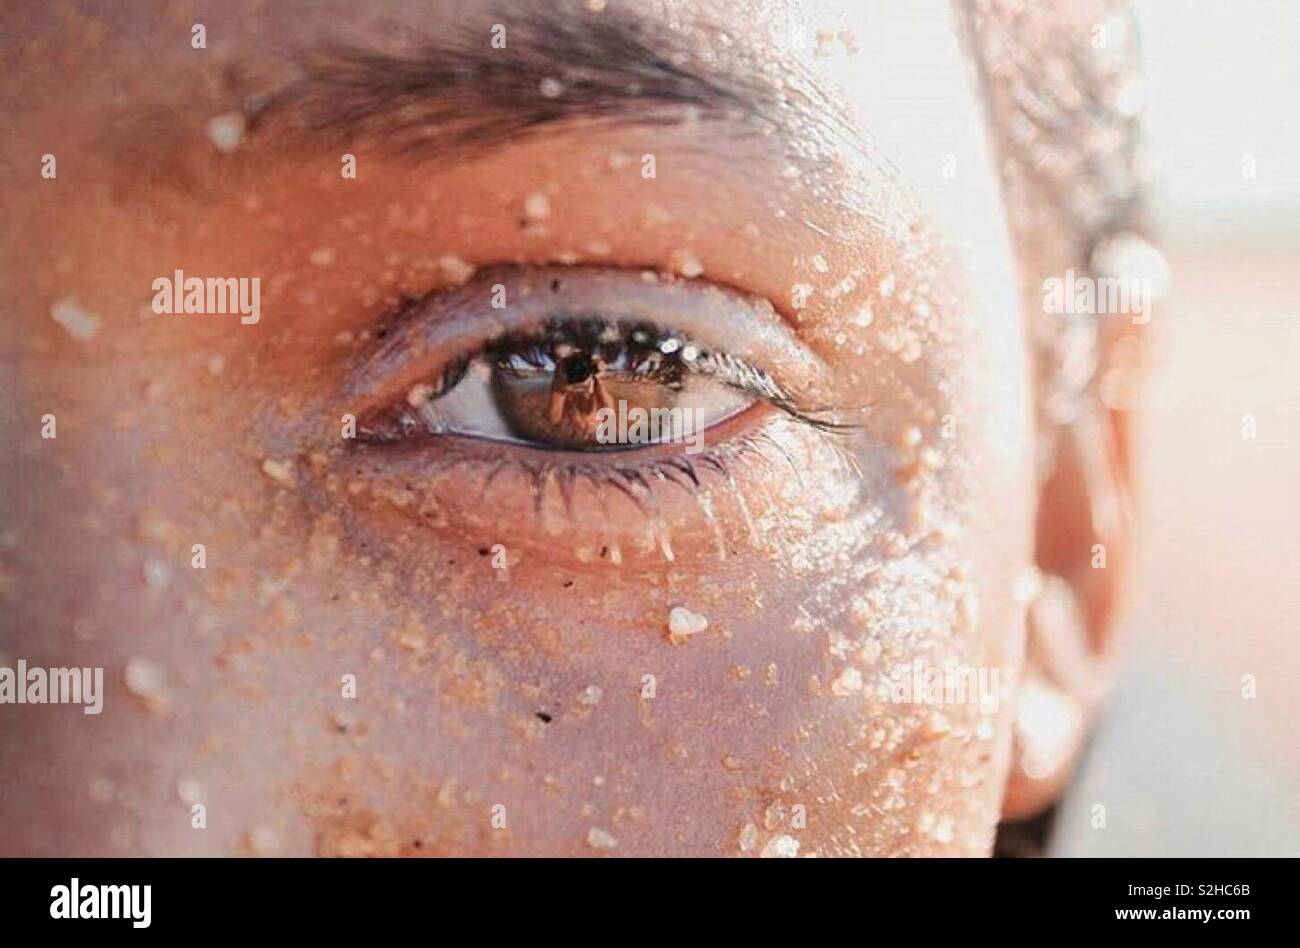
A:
[247,0,785,156]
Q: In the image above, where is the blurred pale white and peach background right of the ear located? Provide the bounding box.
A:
[1054,0,1300,856]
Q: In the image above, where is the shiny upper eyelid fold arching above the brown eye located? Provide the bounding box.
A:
[342,267,833,410]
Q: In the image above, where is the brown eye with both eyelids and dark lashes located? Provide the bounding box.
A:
[323,268,853,562]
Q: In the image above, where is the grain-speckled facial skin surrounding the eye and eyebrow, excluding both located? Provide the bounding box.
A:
[0,3,1036,856]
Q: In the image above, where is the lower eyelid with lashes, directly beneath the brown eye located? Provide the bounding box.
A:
[332,406,858,567]
